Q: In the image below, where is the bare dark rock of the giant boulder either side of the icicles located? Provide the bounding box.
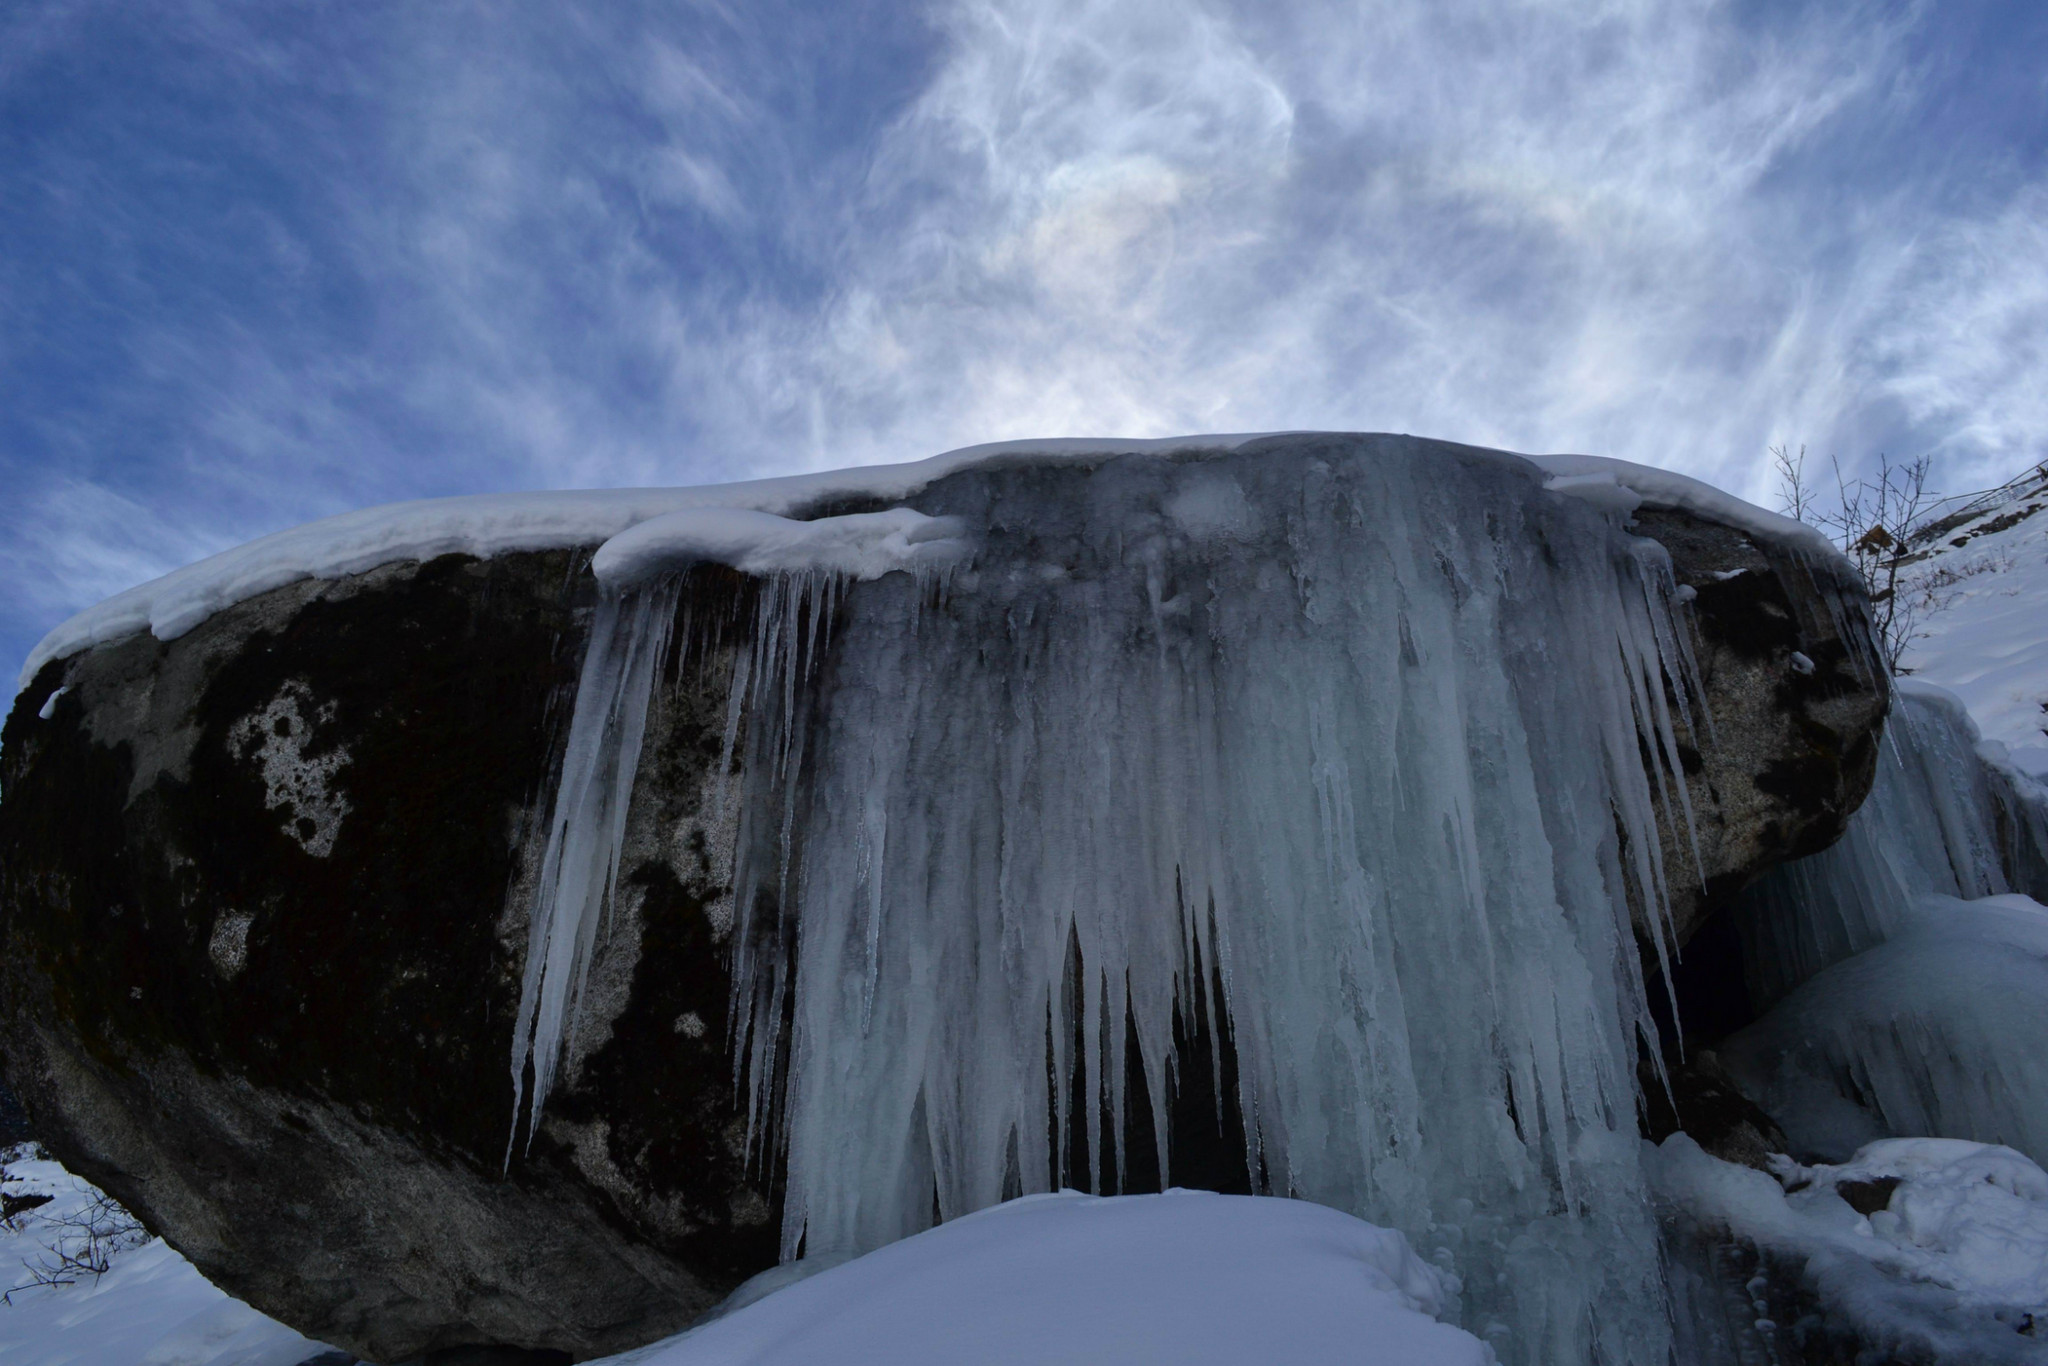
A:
[0,454,1886,1362]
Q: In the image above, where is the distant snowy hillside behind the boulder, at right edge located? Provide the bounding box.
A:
[1901,464,2048,776]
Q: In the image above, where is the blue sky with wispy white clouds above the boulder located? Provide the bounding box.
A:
[0,0,2048,672]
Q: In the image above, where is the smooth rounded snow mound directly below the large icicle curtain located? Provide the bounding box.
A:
[606,1190,1495,1366]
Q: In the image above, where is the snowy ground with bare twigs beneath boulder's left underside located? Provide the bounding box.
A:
[0,1149,335,1366]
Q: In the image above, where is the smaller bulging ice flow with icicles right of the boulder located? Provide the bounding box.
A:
[1724,680,2048,1161]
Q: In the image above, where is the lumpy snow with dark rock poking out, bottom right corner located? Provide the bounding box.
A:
[1645,1135,2048,1366]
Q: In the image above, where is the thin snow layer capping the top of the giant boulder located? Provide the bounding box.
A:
[16,432,1835,688]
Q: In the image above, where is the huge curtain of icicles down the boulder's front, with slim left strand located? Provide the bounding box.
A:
[514,438,1698,1366]
